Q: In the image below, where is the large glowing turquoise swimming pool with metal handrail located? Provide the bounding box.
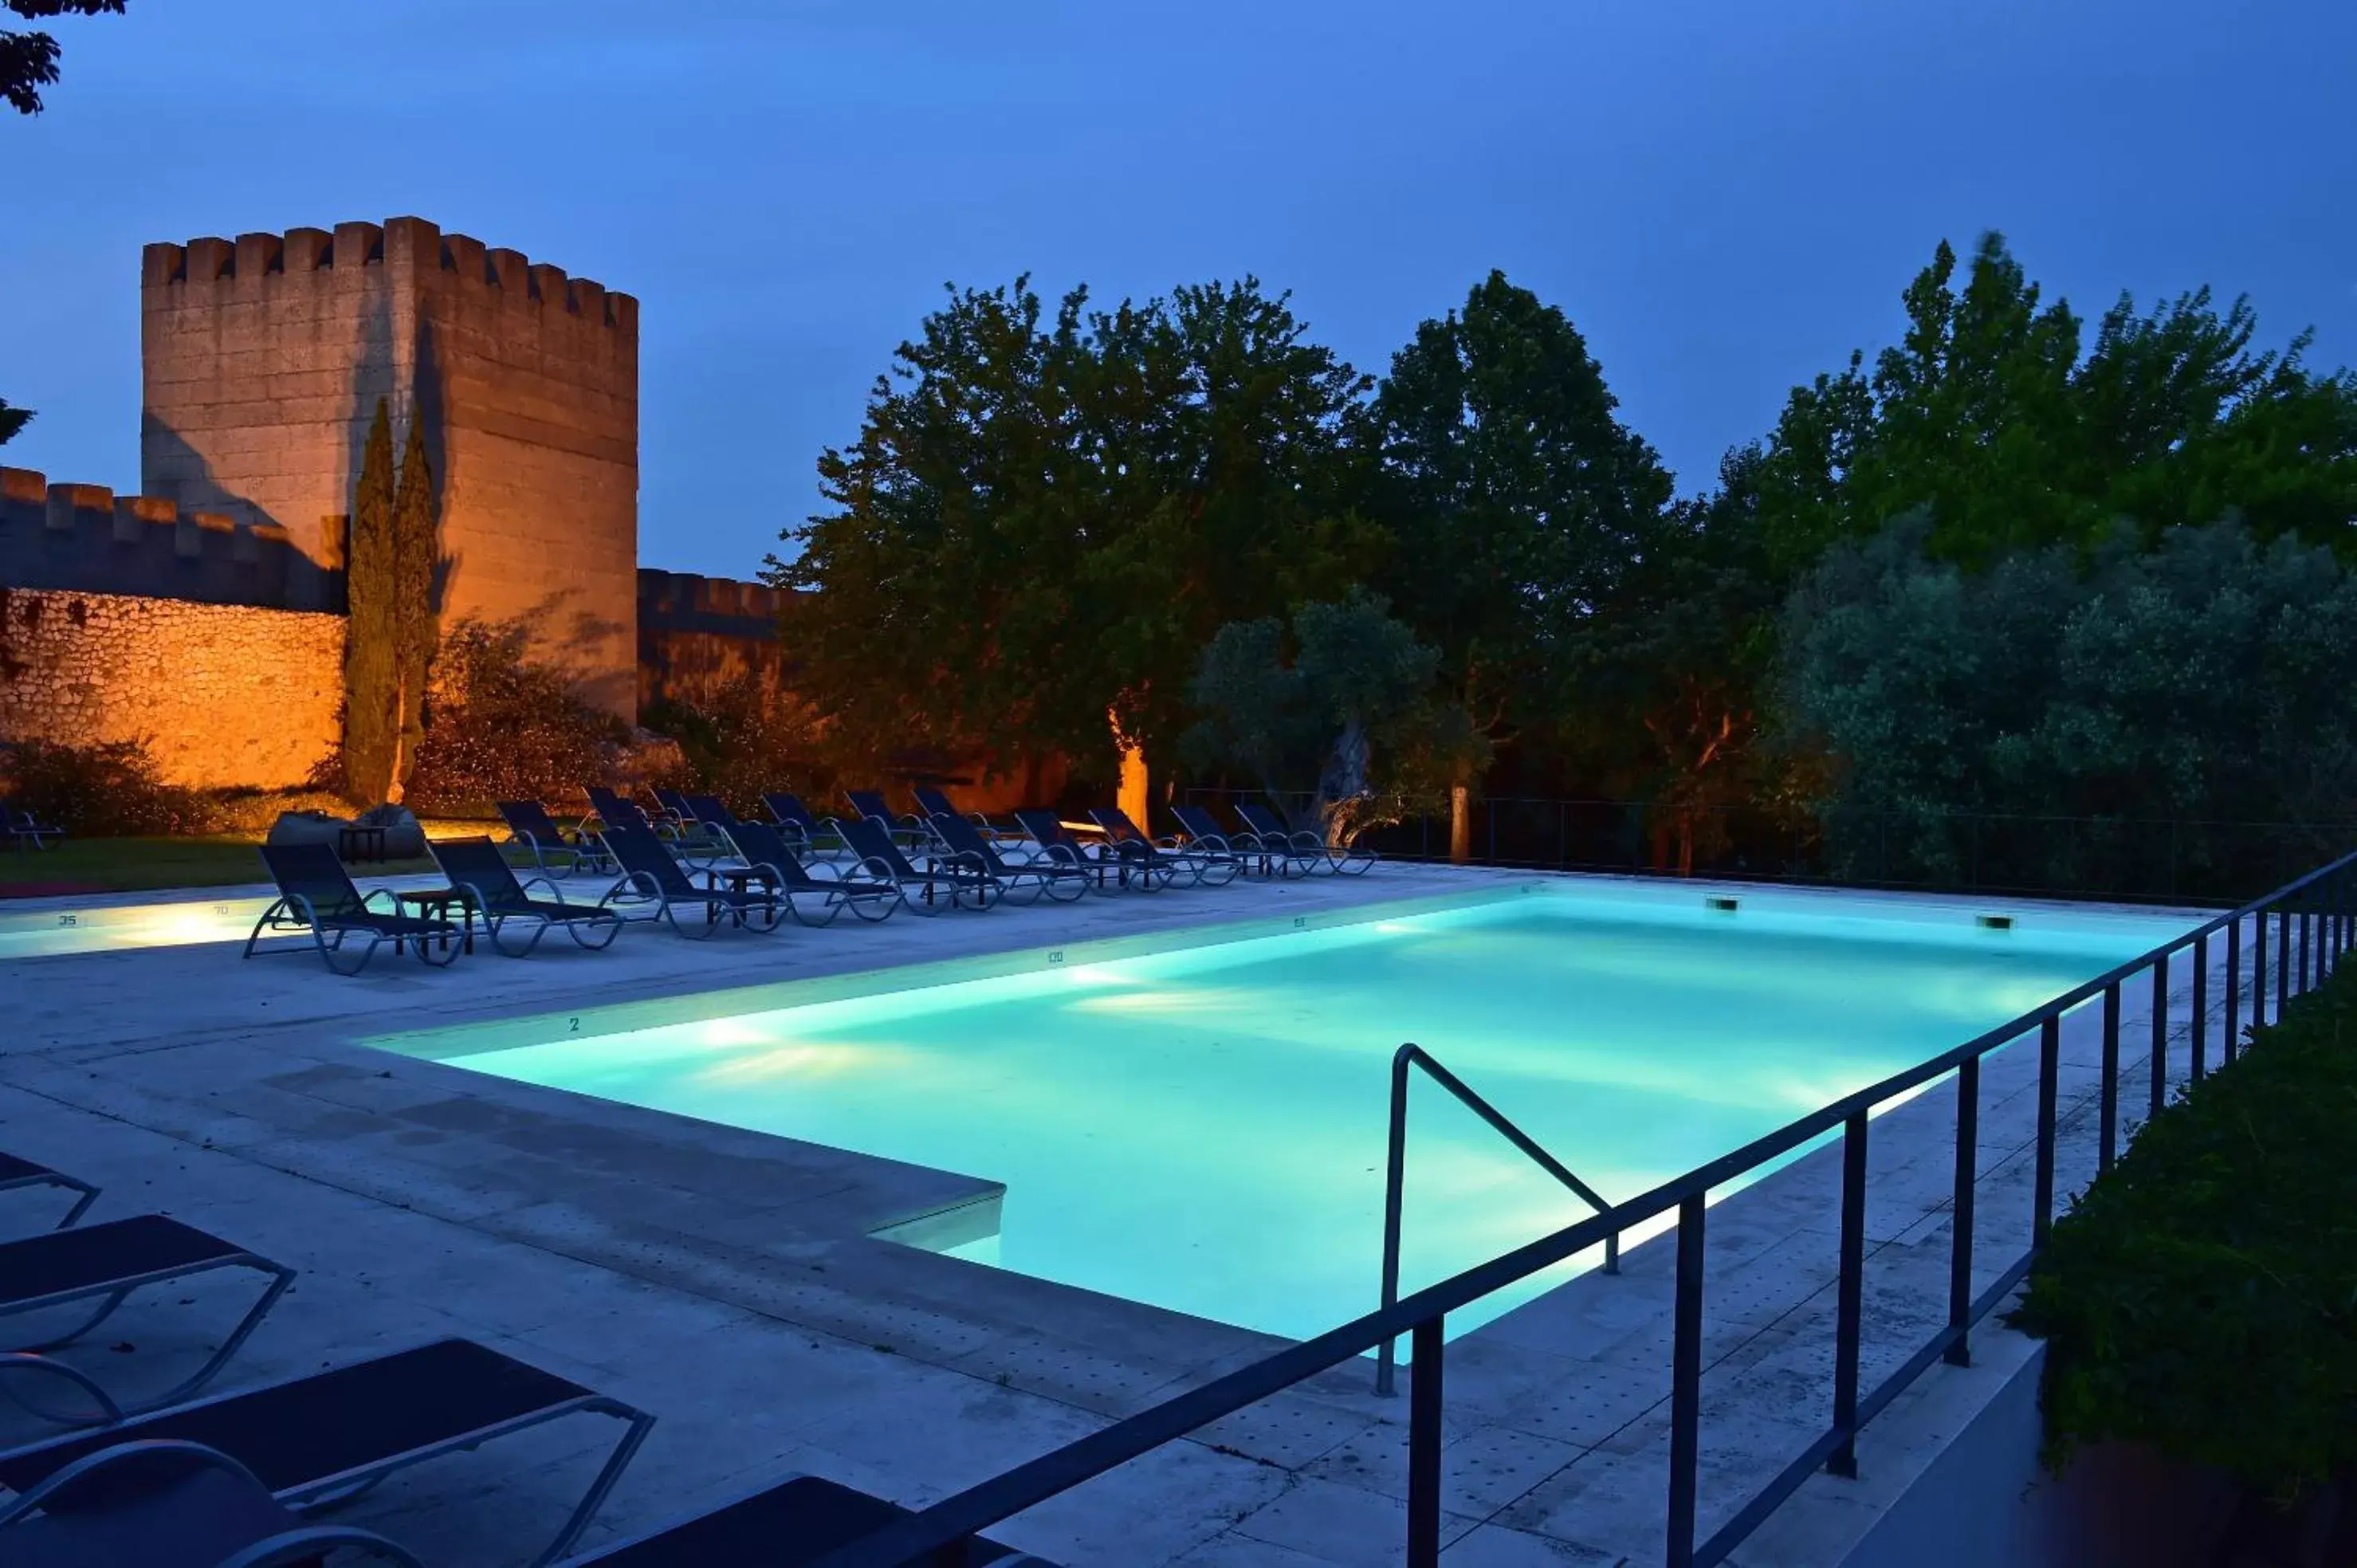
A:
[382,879,2190,1337]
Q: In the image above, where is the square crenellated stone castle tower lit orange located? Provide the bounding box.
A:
[141,217,638,717]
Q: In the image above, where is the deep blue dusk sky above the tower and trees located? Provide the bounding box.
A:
[0,0,2357,576]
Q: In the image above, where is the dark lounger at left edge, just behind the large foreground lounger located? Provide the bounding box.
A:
[0,1214,295,1420]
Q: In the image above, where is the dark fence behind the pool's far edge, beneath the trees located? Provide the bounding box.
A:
[1185,790,2357,903]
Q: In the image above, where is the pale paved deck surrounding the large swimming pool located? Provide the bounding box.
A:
[0,866,2218,1568]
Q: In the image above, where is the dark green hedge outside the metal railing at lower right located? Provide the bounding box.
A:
[2013,943,2357,1497]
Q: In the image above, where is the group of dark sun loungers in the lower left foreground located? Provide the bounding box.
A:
[0,1153,1047,1568]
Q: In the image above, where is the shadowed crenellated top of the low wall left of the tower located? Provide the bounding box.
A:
[0,467,342,611]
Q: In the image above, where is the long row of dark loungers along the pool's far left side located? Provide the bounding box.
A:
[246,788,1374,974]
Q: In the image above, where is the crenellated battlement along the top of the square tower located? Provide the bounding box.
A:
[139,217,638,342]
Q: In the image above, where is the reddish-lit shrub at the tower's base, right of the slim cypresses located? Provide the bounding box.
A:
[403,620,630,812]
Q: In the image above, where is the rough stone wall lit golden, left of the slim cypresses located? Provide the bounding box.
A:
[0,588,344,790]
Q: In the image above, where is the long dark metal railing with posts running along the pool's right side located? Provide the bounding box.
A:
[811,854,2357,1568]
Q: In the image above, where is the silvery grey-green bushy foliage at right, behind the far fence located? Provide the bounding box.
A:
[1780,514,2357,874]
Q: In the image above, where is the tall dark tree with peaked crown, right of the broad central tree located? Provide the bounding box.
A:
[1372,271,1673,858]
